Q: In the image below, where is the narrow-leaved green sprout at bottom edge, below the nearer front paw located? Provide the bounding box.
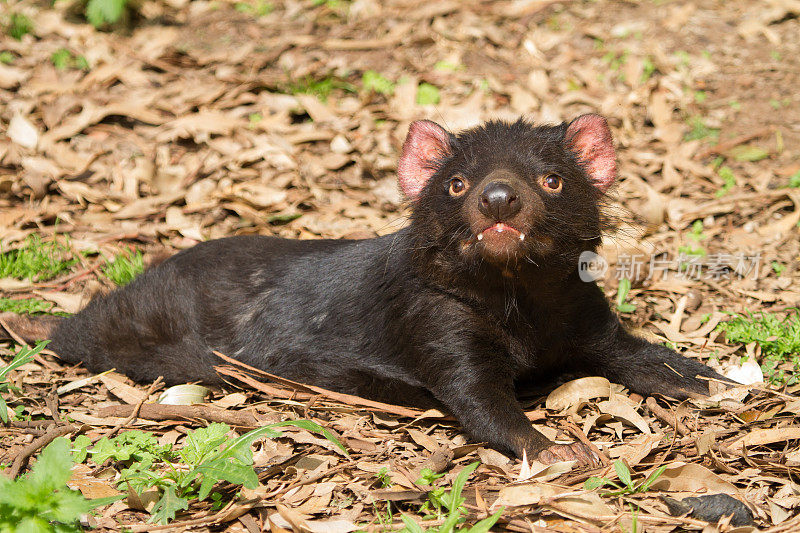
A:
[401,461,504,533]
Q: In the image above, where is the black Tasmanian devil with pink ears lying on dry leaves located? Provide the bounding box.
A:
[0,115,724,463]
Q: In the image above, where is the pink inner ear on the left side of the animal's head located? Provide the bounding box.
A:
[397,120,453,200]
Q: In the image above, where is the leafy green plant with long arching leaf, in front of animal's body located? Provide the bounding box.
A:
[72,420,346,524]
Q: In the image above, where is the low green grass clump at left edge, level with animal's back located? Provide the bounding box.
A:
[0,235,77,281]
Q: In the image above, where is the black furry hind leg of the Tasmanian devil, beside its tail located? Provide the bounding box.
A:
[49,263,225,384]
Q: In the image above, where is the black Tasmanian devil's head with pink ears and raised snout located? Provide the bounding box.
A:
[397,115,617,272]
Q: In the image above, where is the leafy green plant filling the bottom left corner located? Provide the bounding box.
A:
[0,437,124,533]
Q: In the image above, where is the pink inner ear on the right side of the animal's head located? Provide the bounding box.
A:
[564,115,617,193]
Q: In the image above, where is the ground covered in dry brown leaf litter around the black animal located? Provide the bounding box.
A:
[0,0,800,532]
